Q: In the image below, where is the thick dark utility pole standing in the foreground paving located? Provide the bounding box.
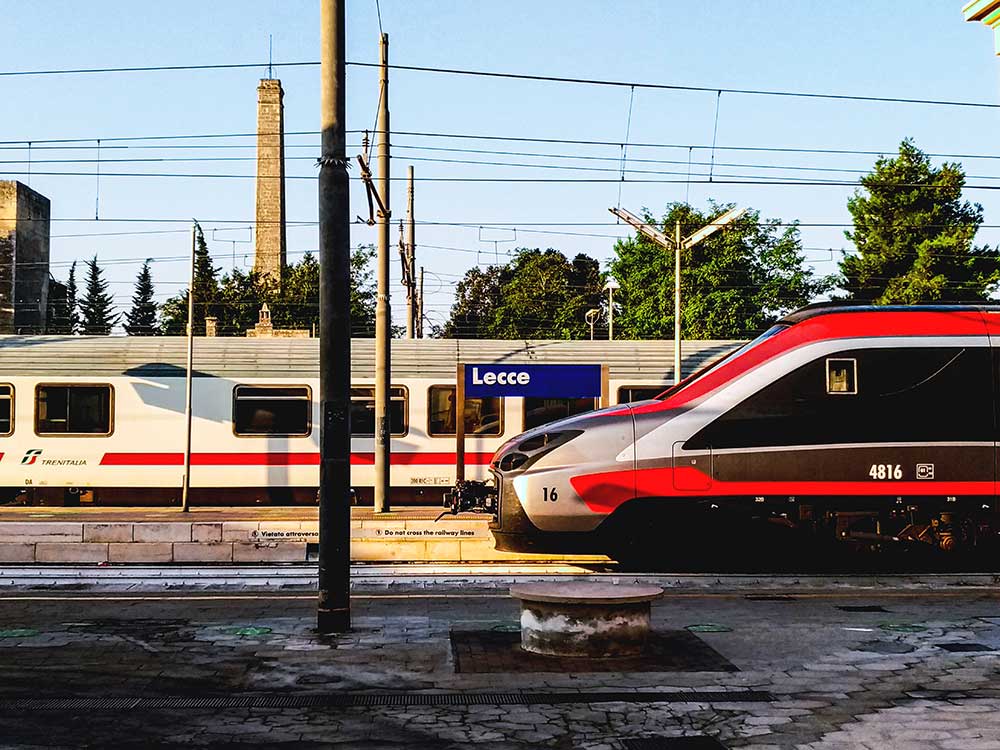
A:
[316,0,351,633]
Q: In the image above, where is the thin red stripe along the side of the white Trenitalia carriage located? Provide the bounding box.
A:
[101,452,493,466]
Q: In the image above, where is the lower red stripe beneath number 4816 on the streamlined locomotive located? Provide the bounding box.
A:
[570,466,996,513]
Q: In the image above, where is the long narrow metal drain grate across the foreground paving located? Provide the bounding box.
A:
[0,690,774,713]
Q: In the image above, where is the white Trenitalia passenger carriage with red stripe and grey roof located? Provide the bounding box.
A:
[0,336,740,505]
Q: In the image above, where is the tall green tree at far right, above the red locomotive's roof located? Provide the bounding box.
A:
[839,140,1000,304]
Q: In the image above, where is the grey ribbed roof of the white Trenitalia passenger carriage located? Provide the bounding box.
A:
[0,336,744,385]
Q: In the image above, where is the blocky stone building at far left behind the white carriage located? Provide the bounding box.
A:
[0,181,50,334]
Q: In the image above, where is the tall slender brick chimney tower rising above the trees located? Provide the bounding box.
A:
[253,78,285,283]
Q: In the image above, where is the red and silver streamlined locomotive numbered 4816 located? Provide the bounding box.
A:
[474,304,1000,557]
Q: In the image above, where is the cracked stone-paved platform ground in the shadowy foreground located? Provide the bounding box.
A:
[0,587,1000,750]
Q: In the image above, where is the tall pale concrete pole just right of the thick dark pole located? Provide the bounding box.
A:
[375,34,392,513]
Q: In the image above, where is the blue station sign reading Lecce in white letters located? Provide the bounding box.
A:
[465,364,601,398]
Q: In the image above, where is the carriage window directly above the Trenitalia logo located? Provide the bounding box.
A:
[35,385,113,435]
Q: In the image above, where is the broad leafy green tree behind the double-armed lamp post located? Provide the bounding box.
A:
[611,202,831,339]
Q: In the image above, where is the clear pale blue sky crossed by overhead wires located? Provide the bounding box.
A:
[0,0,1000,332]
